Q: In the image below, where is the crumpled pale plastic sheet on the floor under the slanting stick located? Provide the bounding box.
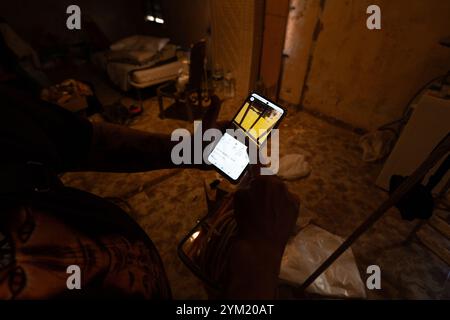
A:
[280,224,366,298]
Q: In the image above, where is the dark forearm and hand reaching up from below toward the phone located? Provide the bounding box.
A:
[225,176,299,299]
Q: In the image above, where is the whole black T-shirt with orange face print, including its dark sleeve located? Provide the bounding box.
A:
[0,88,171,299]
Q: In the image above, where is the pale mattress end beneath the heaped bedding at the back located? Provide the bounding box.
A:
[130,61,183,88]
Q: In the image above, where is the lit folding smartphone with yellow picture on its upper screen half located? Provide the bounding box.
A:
[208,93,286,183]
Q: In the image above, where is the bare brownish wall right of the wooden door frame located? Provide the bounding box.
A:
[282,0,450,129]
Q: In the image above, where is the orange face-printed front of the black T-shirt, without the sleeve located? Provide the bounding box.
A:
[0,195,171,299]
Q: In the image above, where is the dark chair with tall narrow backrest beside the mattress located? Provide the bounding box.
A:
[157,39,212,121]
